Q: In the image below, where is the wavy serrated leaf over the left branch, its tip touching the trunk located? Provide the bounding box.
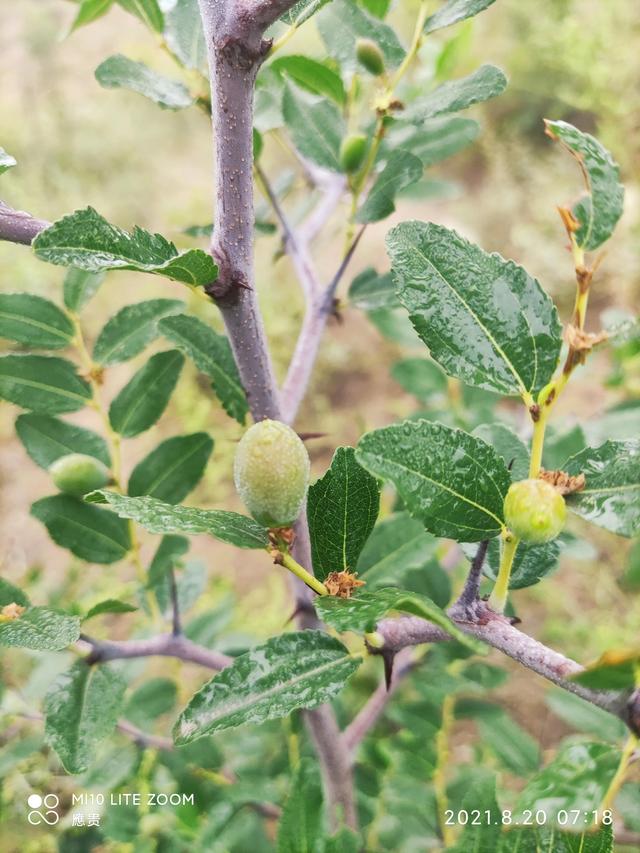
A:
[32,207,218,285]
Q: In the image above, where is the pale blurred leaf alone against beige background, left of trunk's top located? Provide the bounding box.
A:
[95,53,194,110]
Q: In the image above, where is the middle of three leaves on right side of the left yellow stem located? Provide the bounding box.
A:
[109,350,184,438]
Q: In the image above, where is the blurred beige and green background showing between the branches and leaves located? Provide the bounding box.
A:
[0,0,640,851]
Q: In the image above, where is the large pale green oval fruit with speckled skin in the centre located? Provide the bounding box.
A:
[233,420,309,527]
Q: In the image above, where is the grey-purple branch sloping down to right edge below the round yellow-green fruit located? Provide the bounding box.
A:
[371,601,640,733]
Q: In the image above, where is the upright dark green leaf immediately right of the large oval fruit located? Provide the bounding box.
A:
[307,447,380,580]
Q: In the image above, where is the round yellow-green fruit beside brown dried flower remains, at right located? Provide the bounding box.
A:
[504,480,567,544]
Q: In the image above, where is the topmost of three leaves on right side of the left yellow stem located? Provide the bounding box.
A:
[93,299,184,366]
